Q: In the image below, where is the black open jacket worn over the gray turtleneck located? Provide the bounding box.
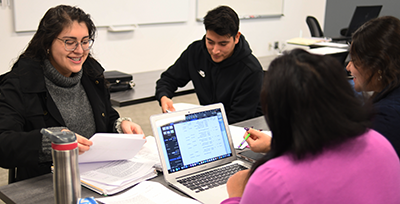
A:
[0,57,119,180]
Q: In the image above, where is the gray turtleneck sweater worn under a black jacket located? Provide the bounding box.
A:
[39,60,96,162]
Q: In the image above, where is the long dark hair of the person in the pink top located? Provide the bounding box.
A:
[251,49,371,173]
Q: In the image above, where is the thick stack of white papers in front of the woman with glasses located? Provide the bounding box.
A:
[78,133,159,195]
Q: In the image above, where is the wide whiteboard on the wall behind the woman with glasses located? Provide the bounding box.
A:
[13,0,189,32]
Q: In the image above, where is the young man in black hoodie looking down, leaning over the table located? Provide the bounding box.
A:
[156,6,263,124]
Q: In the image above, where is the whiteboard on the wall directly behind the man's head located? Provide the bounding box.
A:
[196,0,283,20]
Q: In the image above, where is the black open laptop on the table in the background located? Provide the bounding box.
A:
[332,5,382,41]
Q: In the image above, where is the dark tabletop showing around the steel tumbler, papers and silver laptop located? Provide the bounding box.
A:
[0,116,268,203]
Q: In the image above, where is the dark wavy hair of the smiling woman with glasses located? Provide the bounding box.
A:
[20,5,96,62]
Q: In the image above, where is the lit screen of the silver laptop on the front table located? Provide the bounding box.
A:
[157,108,232,173]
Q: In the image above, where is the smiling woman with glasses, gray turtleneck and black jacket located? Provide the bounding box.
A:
[0,5,143,181]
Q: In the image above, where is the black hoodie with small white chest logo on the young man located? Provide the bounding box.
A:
[156,35,263,124]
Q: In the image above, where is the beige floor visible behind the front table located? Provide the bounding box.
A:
[0,93,199,204]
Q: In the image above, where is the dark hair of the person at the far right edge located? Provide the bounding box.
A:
[350,16,400,101]
